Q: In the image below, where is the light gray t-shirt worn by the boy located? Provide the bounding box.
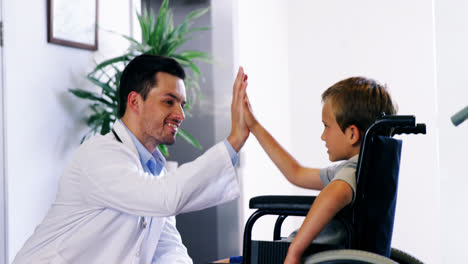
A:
[319,155,359,202]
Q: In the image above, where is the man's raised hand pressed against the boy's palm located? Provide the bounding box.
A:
[227,67,250,152]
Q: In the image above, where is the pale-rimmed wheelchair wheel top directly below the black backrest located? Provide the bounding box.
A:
[304,249,398,264]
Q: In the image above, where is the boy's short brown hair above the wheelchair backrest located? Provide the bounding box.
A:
[322,77,397,138]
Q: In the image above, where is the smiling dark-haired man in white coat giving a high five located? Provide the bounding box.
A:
[13,55,249,264]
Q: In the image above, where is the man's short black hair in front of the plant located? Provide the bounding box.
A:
[117,54,185,118]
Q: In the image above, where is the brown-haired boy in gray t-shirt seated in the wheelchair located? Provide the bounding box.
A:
[244,77,396,264]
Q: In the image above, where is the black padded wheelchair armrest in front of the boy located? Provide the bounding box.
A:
[249,195,315,211]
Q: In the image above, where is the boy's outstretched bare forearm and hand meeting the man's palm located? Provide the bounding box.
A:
[244,95,323,190]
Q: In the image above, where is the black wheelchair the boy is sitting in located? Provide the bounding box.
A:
[242,115,426,264]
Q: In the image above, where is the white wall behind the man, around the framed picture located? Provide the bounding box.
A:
[3,0,140,261]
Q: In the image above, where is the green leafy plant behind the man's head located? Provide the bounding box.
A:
[69,0,209,156]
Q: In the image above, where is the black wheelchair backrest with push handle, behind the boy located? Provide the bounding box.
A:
[351,116,425,257]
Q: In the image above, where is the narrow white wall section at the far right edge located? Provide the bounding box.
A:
[434,0,468,263]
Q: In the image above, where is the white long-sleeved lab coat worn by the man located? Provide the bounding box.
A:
[13,122,240,264]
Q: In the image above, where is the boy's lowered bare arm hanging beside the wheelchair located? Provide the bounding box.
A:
[284,180,353,264]
